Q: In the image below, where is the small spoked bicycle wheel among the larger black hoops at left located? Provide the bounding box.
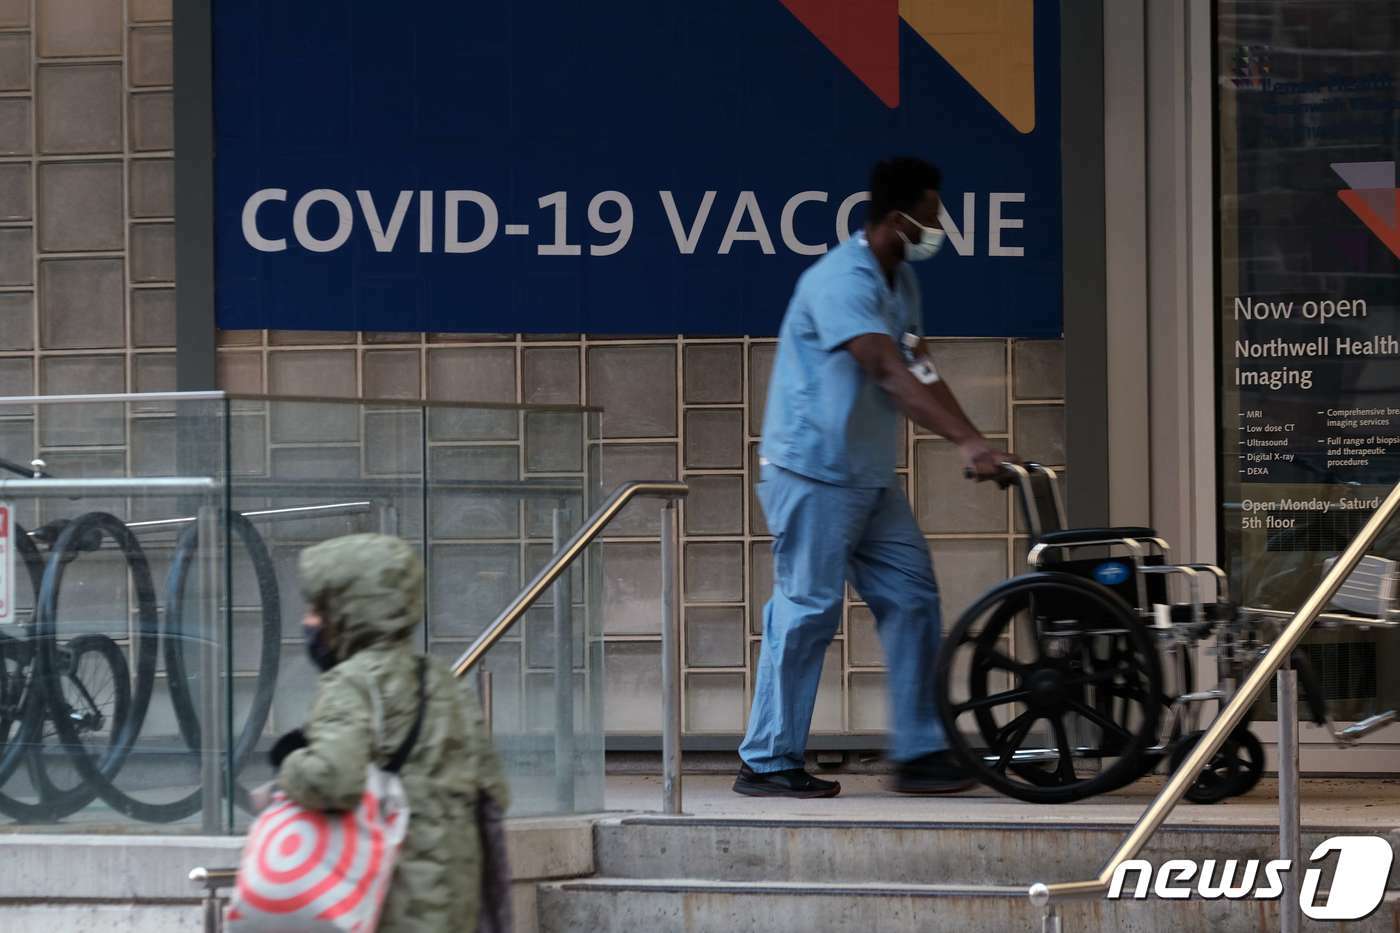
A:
[29,635,132,820]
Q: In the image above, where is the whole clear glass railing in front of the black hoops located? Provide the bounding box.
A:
[0,394,603,832]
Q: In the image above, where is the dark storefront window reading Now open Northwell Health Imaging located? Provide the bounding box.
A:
[1217,0,1400,717]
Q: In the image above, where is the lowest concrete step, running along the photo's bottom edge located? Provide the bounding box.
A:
[539,878,1400,933]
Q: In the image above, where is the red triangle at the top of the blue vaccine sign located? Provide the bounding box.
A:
[783,0,899,108]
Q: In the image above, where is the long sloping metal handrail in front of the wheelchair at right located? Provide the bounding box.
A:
[1028,483,1400,919]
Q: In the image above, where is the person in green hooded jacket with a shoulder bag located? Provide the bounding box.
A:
[273,534,507,933]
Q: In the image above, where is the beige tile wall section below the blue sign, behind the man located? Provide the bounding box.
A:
[218,332,1065,733]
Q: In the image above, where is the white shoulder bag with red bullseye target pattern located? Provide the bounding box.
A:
[227,671,426,933]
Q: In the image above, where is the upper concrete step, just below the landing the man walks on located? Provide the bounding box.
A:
[594,817,1400,891]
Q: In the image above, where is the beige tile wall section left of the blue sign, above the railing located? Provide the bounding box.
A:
[0,0,175,392]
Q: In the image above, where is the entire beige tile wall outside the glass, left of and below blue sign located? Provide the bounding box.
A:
[0,0,1064,733]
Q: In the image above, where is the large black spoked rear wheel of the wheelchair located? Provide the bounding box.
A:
[938,572,1162,803]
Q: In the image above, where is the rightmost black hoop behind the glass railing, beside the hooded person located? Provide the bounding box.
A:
[162,511,281,813]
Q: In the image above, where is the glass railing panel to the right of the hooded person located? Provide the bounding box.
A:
[426,400,603,815]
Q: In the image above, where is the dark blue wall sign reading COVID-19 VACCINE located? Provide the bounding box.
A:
[214,0,1061,336]
